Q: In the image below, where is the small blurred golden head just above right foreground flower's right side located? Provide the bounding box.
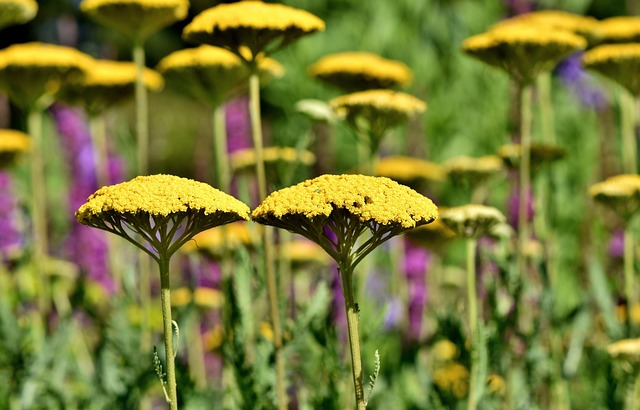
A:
[375,155,445,184]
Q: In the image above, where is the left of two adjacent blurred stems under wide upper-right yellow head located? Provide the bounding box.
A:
[517,85,532,277]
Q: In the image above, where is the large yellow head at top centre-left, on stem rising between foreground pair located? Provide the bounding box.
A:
[182,1,325,62]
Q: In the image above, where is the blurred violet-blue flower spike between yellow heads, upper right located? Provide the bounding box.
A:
[555,53,607,110]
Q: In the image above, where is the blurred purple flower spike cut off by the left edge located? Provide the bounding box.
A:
[0,170,23,262]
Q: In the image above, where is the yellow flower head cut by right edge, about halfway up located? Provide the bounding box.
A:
[589,174,640,220]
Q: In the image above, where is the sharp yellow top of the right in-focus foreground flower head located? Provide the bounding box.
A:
[253,175,438,228]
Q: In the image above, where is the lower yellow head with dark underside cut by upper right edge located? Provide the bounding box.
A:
[582,43,640,96]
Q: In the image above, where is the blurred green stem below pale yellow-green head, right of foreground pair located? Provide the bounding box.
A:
[467,238,478,410]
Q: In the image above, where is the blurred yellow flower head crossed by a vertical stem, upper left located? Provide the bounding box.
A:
[58,60,164,115]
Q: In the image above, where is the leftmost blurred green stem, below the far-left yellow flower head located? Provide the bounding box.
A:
[27,107,51,317]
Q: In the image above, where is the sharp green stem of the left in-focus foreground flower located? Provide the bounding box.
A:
[158,255,178,410]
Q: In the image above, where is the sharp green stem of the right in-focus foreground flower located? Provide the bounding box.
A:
[340,264,367,410]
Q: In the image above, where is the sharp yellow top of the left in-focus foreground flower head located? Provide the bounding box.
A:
[76,174,249,224]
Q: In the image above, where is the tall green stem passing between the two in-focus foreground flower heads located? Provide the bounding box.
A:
[249,67,287,410]
